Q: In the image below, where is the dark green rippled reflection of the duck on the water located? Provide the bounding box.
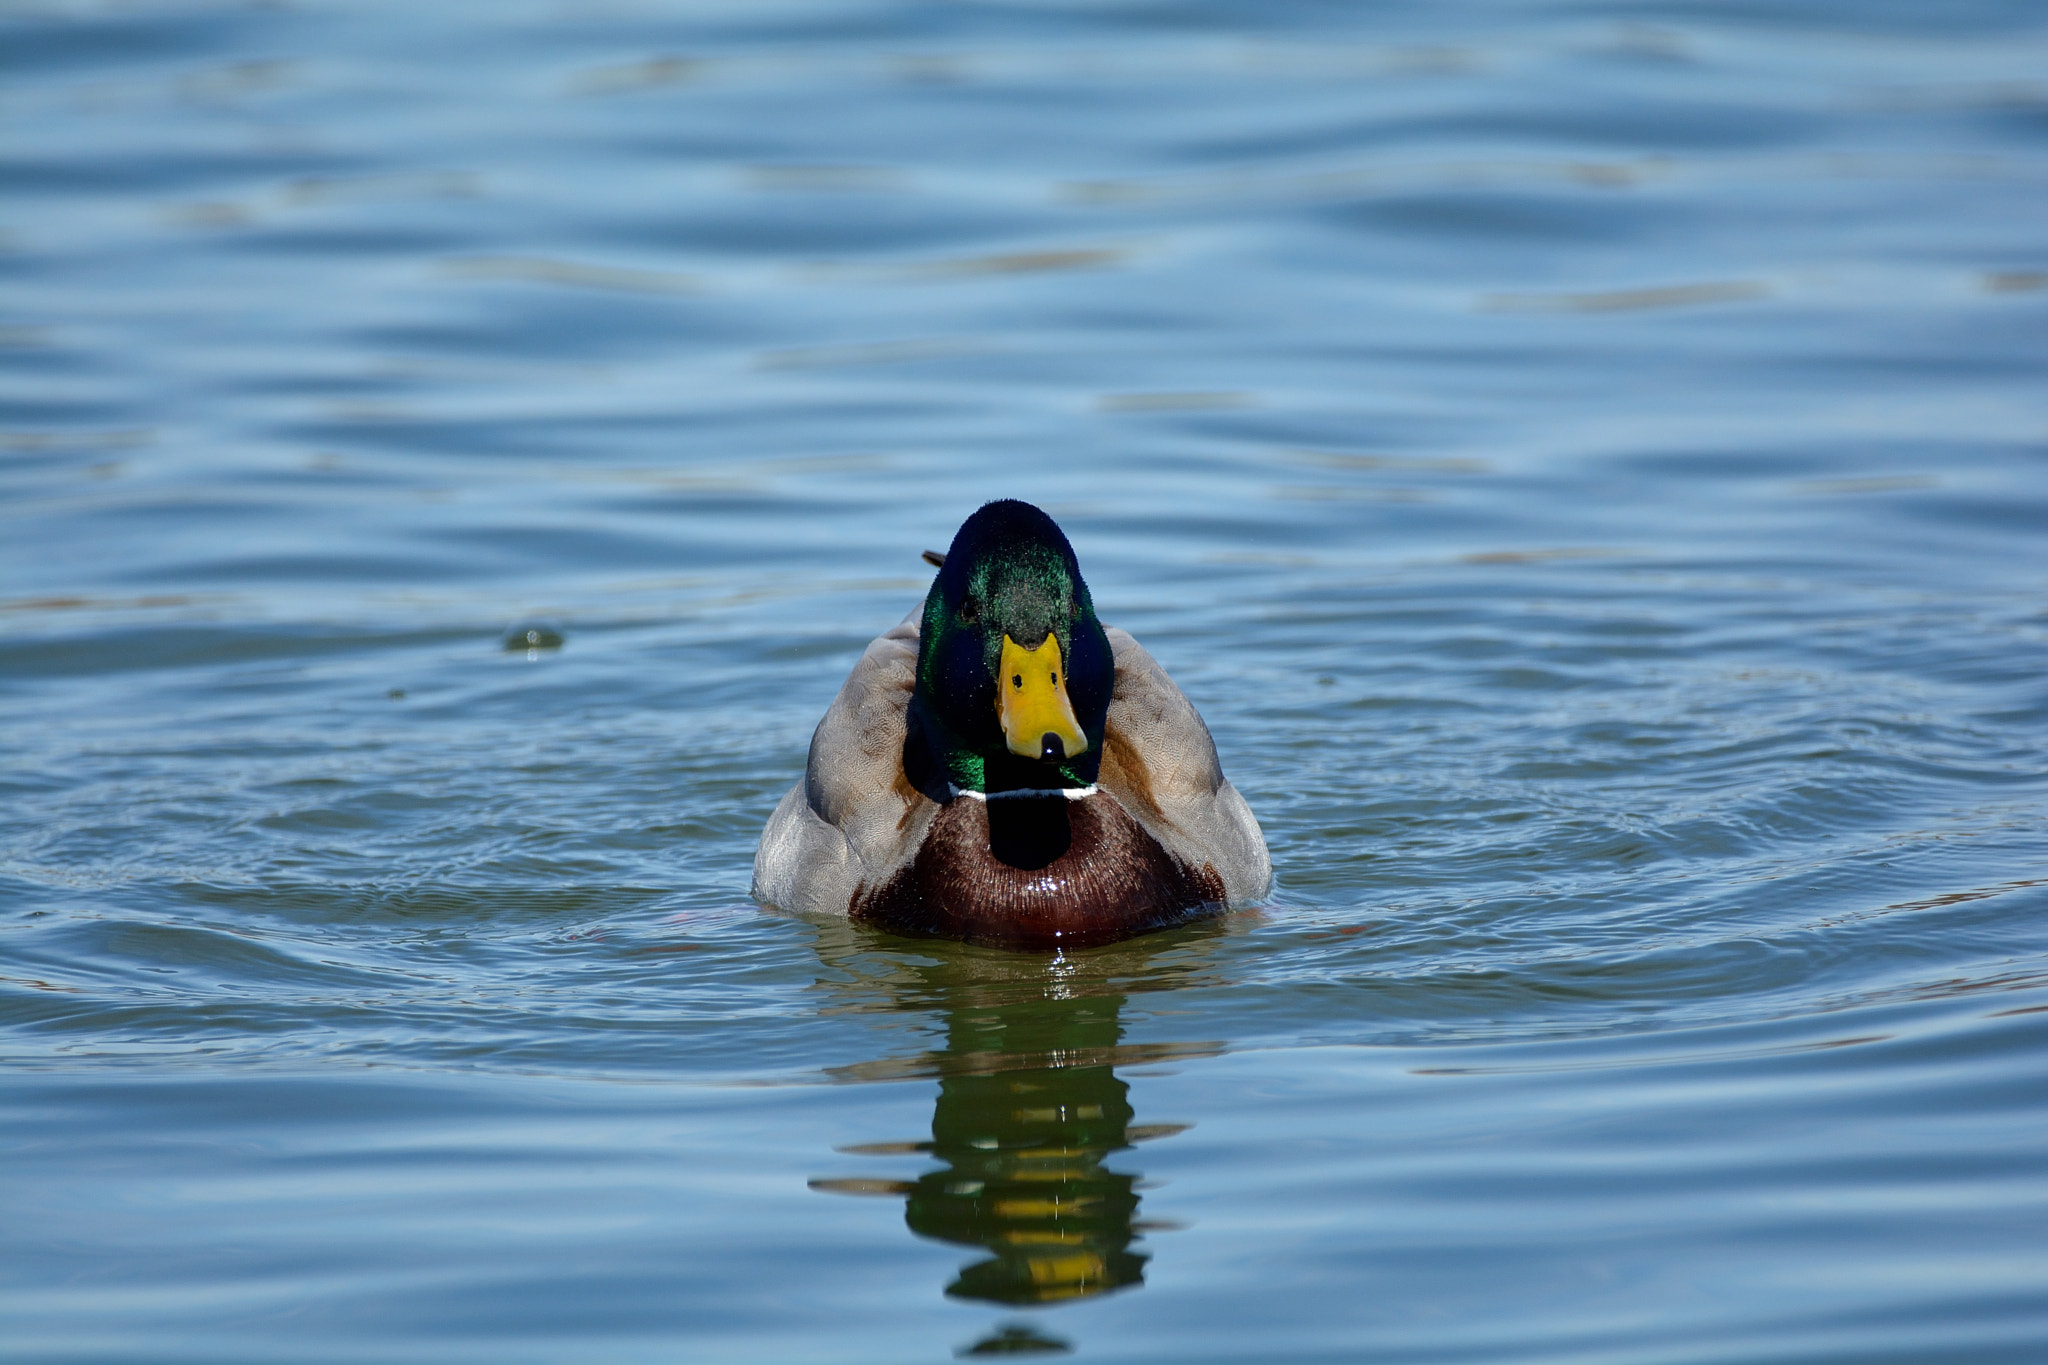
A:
[811,916,1221,1309]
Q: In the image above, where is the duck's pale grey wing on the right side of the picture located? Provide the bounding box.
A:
[1100,626,1274,905]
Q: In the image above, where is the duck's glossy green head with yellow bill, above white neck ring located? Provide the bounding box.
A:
[911,499,1116,792]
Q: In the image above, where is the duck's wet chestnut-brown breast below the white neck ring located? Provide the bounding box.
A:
[850,792,1225,950]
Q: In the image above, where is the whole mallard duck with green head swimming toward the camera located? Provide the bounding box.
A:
[754,499,1272,952]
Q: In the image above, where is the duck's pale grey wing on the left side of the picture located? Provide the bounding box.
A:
[754,612,938,915]
